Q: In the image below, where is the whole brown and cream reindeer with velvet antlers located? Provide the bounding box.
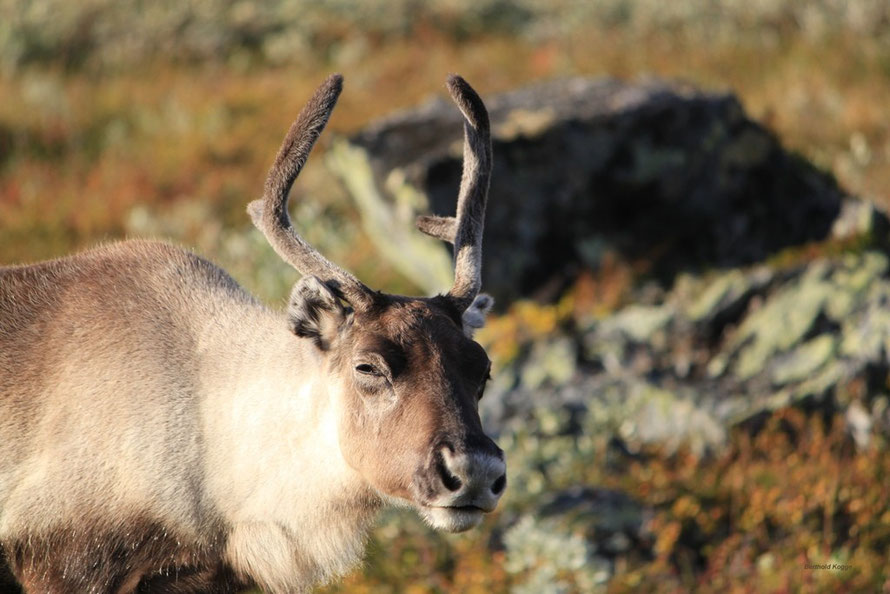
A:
[0,75,506,593]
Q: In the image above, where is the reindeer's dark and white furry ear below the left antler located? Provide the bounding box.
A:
[287,276,350,351]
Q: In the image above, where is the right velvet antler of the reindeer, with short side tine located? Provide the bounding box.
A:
[417,74,491,311]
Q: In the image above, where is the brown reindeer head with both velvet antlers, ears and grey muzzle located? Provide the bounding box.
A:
[248,75,506,532]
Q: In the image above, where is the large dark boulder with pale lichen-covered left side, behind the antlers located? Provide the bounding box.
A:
[327,78,852,298]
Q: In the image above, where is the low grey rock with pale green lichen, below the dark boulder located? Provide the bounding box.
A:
[481,250,890,453]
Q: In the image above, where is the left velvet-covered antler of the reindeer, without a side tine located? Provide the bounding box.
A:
[247,74,372,308]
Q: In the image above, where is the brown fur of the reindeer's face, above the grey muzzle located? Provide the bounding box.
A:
[331,297,503,504]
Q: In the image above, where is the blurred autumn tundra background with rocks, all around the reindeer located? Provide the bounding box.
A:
[0,0,890,593]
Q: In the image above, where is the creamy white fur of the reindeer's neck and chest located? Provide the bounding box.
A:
[196,315,380,592]
